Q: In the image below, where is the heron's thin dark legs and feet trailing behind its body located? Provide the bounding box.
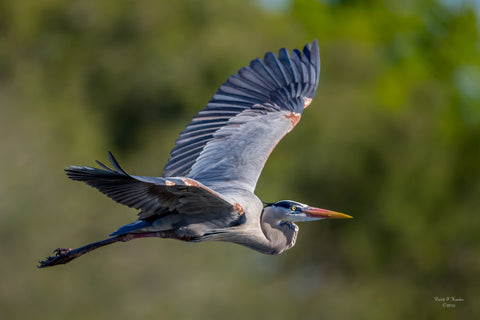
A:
[38,232,161,268]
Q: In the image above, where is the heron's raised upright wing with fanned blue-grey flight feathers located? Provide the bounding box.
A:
[163,40,320,192]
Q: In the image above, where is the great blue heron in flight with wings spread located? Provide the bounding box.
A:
[39,40,351,268]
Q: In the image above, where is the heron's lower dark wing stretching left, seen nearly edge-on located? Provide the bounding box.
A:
[65,152,239,224]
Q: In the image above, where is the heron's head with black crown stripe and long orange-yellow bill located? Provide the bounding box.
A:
[264,200,352,222]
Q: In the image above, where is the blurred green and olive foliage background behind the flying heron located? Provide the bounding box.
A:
[0,0,480,320]
